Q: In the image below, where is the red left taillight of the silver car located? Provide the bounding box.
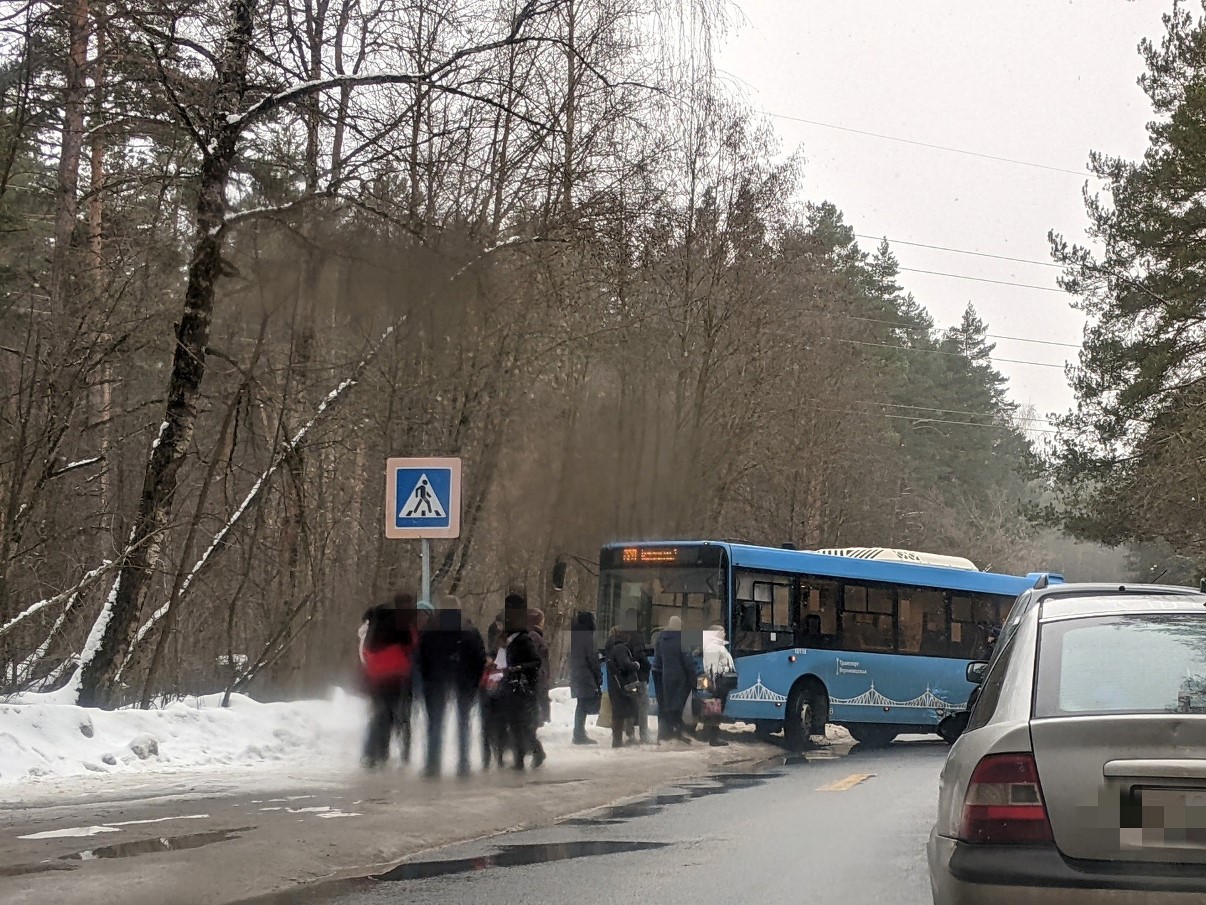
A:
[959,754,1052,845]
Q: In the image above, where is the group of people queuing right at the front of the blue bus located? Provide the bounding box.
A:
[569,609,736,748]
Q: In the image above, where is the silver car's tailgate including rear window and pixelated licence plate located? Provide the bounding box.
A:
[1030,608,1206,864]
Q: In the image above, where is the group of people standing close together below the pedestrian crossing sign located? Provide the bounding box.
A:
[359,592,551,777]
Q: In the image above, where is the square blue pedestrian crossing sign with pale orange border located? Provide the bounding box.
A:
[385,459,461,538]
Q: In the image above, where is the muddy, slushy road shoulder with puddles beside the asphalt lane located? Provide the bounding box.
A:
[0,742,781,905]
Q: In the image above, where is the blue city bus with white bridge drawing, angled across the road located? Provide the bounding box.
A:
[598,541,1059,749]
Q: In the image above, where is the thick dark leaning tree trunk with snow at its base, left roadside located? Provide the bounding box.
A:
[76,0,257,707]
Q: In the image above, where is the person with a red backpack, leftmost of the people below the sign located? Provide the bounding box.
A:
[361,594,417,767]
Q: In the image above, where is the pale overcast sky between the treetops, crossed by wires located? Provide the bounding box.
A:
[720,0,1171,427]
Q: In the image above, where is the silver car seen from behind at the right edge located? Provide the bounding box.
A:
[929,584,1206,905]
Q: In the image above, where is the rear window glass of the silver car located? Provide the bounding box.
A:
[1034,613,1206,718]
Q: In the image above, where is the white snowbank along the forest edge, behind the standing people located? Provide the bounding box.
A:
[0,688,660,786]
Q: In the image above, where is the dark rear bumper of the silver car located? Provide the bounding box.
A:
[929,834,1206,905]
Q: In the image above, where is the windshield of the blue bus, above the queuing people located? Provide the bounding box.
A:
[598,566,725,638]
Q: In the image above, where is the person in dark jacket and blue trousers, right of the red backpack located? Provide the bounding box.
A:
[418,596,486,776]
